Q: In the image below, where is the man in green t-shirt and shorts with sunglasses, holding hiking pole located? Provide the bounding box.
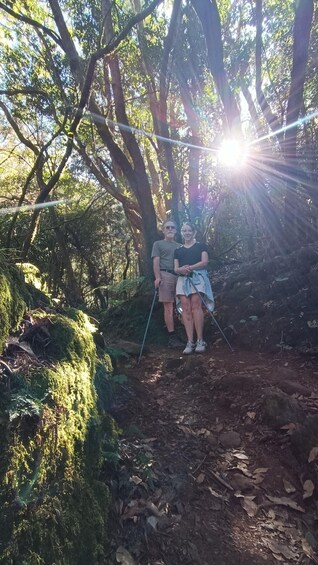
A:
[151,220,182,348]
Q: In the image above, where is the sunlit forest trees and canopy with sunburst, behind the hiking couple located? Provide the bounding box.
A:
[0,0,318,307]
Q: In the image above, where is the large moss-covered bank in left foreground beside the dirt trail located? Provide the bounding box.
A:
[0,310,118,565]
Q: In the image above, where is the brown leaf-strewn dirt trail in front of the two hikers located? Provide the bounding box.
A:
[109,340,318,565]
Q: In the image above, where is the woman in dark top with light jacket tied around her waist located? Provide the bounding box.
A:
[174,222,214,355]
